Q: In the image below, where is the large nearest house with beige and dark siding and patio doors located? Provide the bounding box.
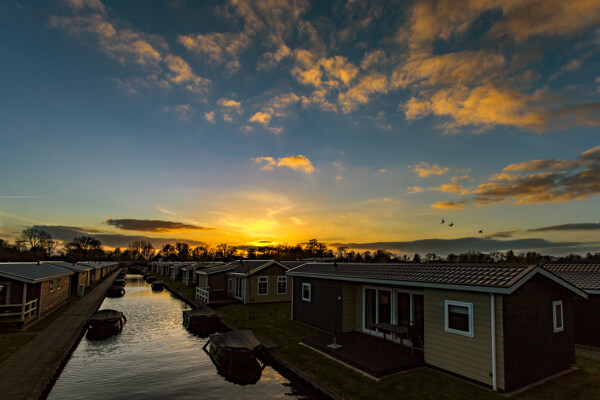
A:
[287,263,587,392]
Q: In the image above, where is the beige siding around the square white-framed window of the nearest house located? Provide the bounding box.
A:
[424,289,505,390]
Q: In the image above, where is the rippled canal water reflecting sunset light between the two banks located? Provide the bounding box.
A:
[48,275,305,400]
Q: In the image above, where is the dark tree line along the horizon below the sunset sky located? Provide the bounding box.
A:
[0,228,600,264]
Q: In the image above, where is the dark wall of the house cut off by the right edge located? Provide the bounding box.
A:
[575,294,600,347]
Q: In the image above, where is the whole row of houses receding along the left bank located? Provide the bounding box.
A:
[0,261,119,327]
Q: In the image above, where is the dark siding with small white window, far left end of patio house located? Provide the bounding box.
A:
[293,277,343,332]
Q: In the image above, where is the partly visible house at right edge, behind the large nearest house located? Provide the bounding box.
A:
[543,264,600,347]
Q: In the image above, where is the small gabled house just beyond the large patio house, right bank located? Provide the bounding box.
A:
[225,260,292,304]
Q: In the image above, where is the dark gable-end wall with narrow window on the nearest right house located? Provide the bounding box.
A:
[504,275,575,391]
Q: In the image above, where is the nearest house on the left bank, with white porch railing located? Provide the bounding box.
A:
[0,262,74,326]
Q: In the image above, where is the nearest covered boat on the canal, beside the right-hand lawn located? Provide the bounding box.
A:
[204,330,265,385]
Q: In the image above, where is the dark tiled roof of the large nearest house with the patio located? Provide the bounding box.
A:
[287,263,587,297]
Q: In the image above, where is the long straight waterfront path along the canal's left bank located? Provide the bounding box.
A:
[0,270,119,400]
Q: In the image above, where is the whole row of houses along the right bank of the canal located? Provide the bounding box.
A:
[149,260,600,392]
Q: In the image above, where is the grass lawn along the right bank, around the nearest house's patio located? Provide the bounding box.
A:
[218,303,600,400]
